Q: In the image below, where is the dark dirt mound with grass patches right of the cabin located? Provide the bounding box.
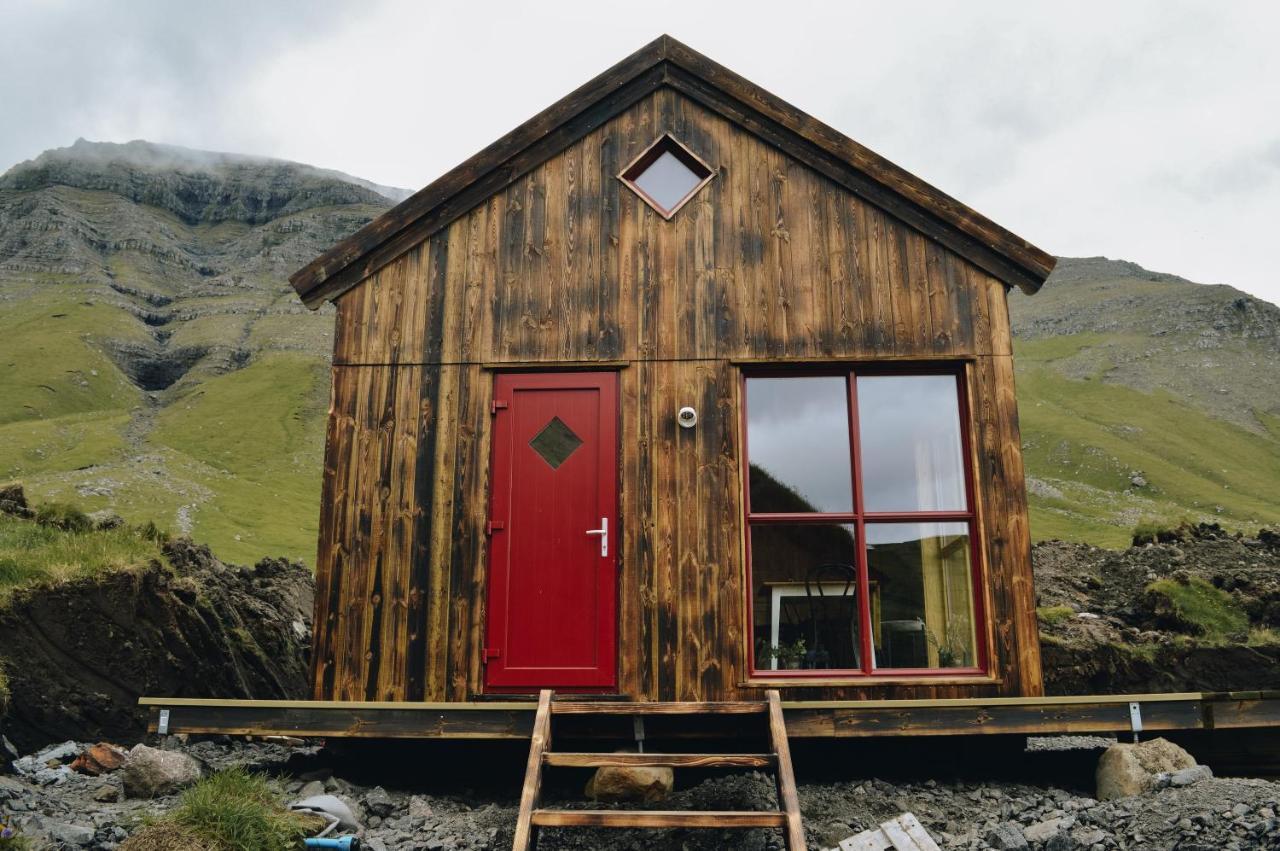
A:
[1032,523,1280,695]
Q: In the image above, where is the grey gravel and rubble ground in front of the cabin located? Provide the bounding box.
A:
[0,738,1280,851]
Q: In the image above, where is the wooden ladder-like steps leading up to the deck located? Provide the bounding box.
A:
[512,690,805,851]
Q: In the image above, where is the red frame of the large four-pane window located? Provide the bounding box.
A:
[739,363,989,681]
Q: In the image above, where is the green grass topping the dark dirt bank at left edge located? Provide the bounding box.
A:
[0,514,160,600]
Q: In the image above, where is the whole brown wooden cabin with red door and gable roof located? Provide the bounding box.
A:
[292,36,1053,703]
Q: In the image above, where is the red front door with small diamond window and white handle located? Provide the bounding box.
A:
[484,372,620,692]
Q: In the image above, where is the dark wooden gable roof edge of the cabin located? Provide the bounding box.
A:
[289,36,1056,308]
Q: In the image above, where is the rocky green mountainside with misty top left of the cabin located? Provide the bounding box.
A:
[0,141,394,563]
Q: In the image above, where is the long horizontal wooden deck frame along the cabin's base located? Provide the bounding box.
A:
[138,691,1280,740]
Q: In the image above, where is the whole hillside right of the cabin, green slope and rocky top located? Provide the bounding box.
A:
[1010,258,1280,546]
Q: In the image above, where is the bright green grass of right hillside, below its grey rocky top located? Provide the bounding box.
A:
[1018,335,1280,546]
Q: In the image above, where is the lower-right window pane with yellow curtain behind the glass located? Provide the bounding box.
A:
[867,523,978,668]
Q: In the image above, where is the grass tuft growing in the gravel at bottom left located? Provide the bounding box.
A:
[157,768,308,851]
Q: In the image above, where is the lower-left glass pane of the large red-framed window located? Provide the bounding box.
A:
[751,523,863,671]
